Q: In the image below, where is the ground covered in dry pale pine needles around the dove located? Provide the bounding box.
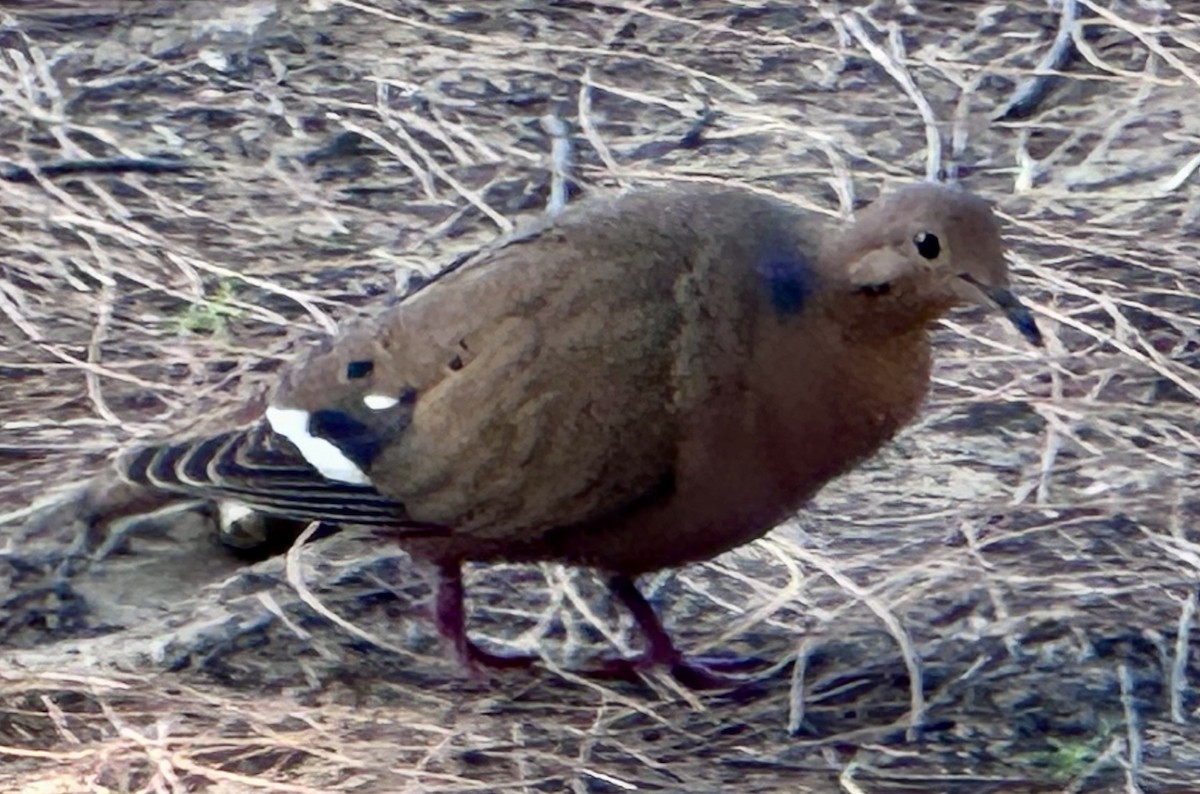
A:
[0,0,1200,793]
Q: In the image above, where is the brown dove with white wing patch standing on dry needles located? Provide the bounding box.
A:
[105,178,1040,685]
